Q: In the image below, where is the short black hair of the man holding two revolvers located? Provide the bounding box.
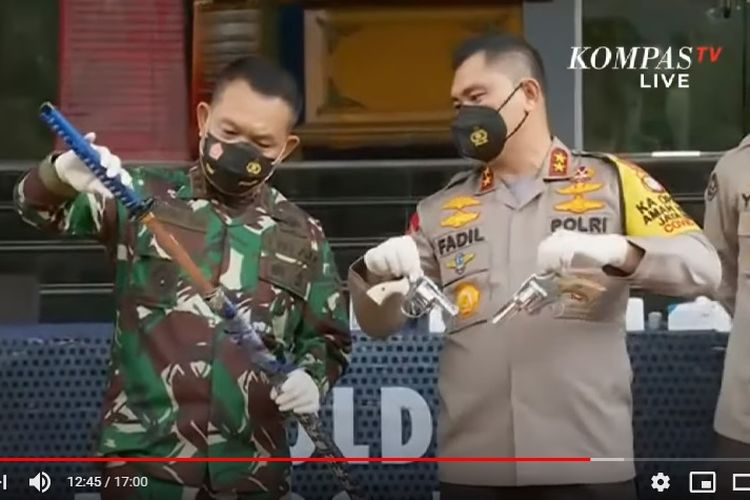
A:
[453,33,547,90]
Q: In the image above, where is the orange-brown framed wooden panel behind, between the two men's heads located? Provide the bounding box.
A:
[300,2,522,146]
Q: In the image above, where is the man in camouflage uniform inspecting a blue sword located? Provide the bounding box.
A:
[15,58,351,500]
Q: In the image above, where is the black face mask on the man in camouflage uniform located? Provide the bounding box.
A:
[200,133,276,196]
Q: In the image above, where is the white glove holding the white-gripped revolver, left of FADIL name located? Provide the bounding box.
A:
[365,236,424,280]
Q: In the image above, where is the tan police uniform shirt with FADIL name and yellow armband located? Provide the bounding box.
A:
[349,140,720,485]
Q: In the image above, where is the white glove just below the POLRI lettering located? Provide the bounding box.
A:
[537,229,629,273]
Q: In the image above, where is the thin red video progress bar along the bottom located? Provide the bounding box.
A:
[0,457,591,462]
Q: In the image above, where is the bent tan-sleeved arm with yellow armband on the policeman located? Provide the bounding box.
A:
[617,156,721,297]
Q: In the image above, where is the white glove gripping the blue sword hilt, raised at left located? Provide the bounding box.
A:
[54,132,133,198]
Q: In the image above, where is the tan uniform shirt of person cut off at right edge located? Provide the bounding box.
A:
[705,135,750,443]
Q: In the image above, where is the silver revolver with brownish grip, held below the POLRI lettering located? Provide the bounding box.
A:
[492,273,605,324]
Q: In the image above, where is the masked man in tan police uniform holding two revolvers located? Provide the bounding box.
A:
[349,35,720,500]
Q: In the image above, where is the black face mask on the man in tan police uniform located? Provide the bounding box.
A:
[451,84,529,163]
